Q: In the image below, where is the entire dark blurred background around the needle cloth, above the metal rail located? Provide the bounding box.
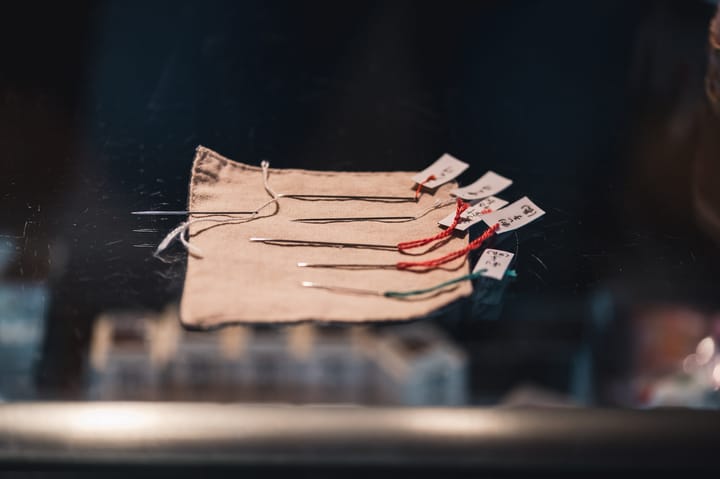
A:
[0,0,720,408]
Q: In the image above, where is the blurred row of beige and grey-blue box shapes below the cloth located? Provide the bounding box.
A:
[88,307,467,405]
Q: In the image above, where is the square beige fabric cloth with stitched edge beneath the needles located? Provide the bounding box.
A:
[180,147,472,328]
